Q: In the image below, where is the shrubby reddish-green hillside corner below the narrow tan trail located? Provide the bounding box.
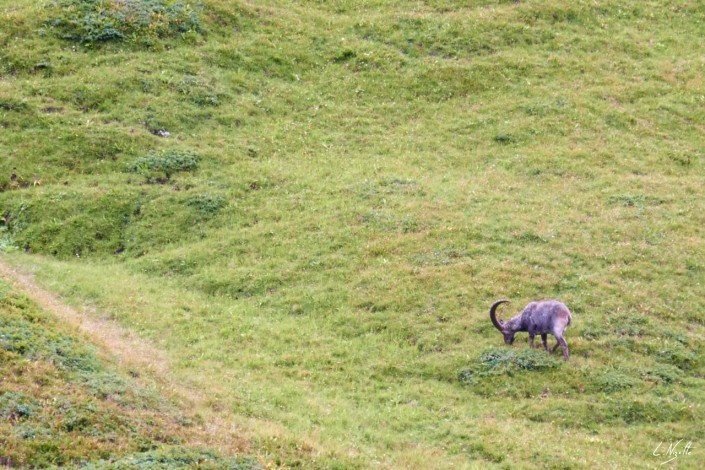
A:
[0,282,259,469]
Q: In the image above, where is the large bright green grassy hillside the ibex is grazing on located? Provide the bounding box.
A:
[0,0,705,468]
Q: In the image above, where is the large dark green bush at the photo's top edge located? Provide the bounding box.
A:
[49,0,203,45]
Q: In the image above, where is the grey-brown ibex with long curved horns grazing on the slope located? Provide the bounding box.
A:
[490,300,571,361]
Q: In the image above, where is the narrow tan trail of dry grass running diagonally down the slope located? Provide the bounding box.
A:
[0,255,253,458]
